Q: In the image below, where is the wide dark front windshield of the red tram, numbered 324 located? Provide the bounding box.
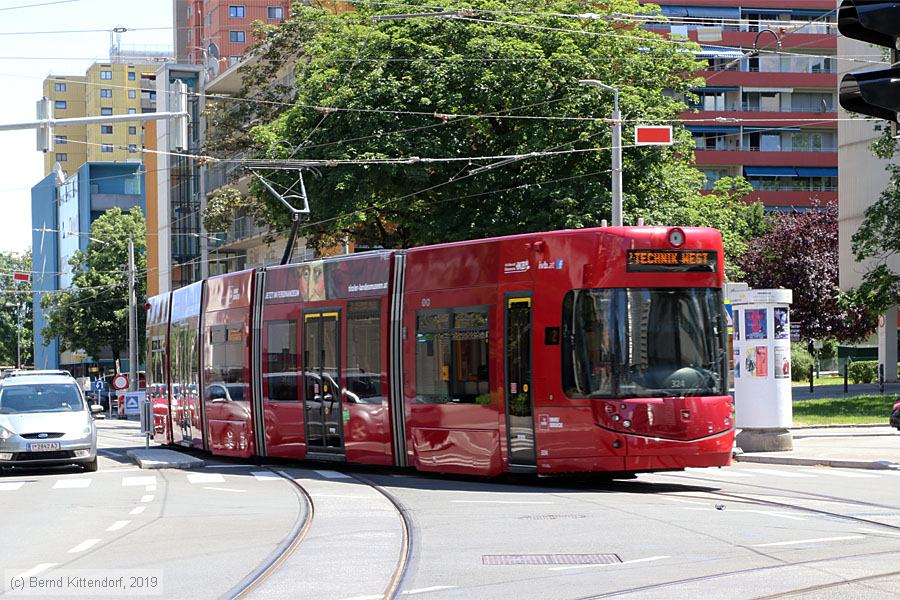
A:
[562,288,727,398]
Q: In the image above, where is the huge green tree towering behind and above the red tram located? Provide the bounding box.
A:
[202,0,731,247]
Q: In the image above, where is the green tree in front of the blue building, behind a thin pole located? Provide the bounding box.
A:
[41,208,147,359]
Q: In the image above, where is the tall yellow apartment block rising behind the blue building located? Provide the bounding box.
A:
[44,62,159,175]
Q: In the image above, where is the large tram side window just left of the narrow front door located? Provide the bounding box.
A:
[416,309,490,405]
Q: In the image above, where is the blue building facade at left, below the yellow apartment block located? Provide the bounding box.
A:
[31,163,146,376]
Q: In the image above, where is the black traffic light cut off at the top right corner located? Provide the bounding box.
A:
[838,0,900,125]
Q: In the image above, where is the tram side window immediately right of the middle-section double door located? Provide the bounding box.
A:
[344,300,383,404]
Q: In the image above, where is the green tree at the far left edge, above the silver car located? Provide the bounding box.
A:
[0,250,34,365]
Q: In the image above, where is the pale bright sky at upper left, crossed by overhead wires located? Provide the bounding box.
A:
[0,0,174,252]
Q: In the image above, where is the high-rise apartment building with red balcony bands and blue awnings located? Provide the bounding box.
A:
[647,0,838,210]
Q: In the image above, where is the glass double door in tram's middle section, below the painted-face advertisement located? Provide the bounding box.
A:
[303,311,344,452]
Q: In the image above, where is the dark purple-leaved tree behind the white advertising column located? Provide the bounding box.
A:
[739,203,877,342]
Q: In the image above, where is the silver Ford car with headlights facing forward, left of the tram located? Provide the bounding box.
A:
[0,374,101,471]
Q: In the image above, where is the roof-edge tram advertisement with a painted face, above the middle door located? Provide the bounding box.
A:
[265,255,390,303]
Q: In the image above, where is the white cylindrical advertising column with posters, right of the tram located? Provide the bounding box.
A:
[731,290,793,452]
